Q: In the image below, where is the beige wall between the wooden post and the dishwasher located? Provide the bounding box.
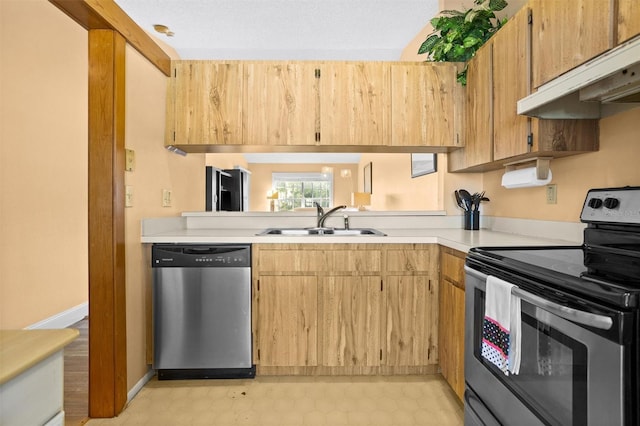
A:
[125,46,205,389]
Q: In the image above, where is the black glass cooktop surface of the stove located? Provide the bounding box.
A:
[467,246,640,307]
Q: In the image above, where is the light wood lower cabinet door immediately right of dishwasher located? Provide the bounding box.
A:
[256,276,318,367]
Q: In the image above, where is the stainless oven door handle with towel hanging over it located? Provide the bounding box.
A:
[464,266,613,330]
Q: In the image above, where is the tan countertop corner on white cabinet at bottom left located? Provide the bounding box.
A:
[0,328,79,384]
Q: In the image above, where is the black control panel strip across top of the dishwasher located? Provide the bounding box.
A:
[151,244,251,268]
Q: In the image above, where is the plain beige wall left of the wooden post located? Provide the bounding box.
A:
[0,0,88,329]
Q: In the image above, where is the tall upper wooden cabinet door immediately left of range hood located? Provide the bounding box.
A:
[492,7,531,161]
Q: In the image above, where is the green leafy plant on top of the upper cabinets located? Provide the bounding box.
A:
[418,0,507,85]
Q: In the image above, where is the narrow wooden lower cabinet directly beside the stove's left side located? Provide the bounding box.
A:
[438,247,465,400]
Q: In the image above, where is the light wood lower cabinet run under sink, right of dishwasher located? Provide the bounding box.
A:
[253,244,438,375]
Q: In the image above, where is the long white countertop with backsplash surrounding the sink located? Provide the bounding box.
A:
[141,211,584,252]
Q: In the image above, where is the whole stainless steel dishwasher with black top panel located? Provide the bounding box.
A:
[151,244,255,380]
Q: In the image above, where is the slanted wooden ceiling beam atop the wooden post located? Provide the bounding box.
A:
[49,0,171,77]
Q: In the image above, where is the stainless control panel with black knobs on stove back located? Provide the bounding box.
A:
[580,186,640,225]
